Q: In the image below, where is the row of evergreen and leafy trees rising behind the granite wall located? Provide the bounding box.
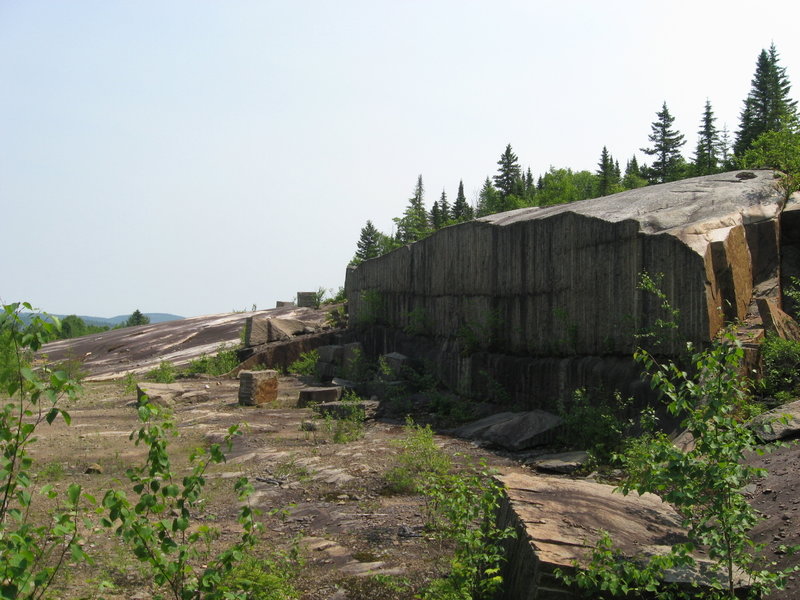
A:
[350,44,800,265]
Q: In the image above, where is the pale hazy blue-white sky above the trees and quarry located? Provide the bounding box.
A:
[0,0,800,317]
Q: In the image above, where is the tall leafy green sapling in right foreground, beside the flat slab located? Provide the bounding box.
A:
[620,334,781,598]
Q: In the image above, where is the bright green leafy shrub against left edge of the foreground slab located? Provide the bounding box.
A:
[420,464,515,600]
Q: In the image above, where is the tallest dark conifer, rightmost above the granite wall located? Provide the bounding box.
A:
[733,44,797,157]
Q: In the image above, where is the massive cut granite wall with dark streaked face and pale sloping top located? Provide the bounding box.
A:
[346,170,797,408]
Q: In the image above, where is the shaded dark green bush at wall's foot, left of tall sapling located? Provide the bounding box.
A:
[558,389,634,464]
